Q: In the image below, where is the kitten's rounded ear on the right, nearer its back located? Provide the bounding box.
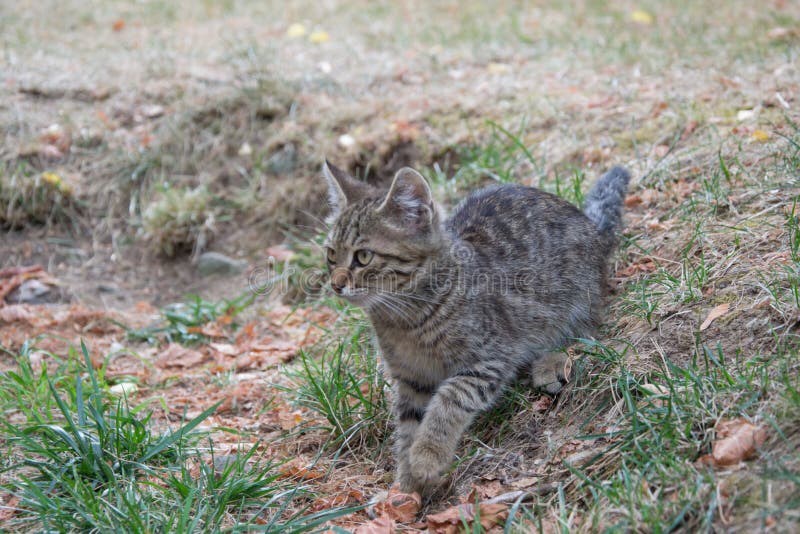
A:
[377,167,436,228]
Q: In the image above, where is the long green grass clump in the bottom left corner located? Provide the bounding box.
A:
[0,345,348,532]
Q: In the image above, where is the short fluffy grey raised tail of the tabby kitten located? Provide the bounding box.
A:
[583,167,631,251]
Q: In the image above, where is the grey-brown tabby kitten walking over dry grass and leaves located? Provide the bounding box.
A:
[322,161,630,495]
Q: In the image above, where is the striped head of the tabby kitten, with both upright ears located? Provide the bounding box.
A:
[322,161,443,307]
